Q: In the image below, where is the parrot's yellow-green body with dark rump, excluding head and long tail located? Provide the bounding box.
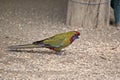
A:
[34,31,74,50]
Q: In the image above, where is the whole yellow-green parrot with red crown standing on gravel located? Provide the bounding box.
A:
[9,31,80,54]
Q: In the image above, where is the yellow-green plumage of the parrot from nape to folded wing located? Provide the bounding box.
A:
[43,31,75,48]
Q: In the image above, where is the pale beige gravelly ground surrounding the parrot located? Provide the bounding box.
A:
[0,0,120,80]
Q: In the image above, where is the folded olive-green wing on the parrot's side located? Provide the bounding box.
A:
[43,35,66,48]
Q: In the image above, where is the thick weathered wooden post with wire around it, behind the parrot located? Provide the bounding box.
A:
[66,0,110,28]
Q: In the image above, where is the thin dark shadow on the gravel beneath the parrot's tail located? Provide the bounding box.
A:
[8,49,56,54]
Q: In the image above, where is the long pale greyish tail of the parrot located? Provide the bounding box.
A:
[8,44,40,50]
